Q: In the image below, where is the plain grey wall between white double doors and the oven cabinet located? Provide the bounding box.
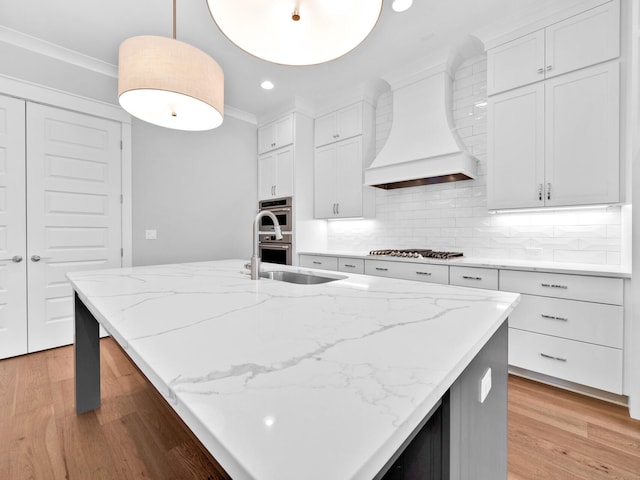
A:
[132,116,257,265]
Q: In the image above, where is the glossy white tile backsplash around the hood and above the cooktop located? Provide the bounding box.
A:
[328,55,623,265]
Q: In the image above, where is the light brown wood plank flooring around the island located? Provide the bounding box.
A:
[0,338,640,480]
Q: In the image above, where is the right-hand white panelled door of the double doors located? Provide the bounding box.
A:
[27,103,121,352]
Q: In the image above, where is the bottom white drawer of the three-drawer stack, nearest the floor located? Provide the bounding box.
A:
[509,328,622,394]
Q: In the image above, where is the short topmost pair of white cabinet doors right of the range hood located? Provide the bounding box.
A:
[487,0,620,95]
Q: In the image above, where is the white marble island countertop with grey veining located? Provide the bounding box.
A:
[68,260,519,480]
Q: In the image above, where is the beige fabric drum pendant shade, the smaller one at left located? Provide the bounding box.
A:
[118,35,224,130]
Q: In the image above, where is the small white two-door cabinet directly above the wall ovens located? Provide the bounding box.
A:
[258,147,293,200]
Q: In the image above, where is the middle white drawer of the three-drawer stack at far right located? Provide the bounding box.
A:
[509,295,623,348]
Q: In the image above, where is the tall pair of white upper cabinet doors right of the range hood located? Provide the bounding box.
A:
[487,62,620,209]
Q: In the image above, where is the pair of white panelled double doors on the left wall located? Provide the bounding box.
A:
[0,95,122,358]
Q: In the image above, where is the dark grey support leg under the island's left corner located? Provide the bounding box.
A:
[74,293,100,415]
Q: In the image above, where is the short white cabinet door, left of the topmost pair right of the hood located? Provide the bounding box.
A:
[487,30,544,95]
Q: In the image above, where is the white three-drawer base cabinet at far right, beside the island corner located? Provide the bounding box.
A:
[499,270,623,394]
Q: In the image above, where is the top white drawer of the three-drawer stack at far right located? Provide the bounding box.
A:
[500,270,623,305]
